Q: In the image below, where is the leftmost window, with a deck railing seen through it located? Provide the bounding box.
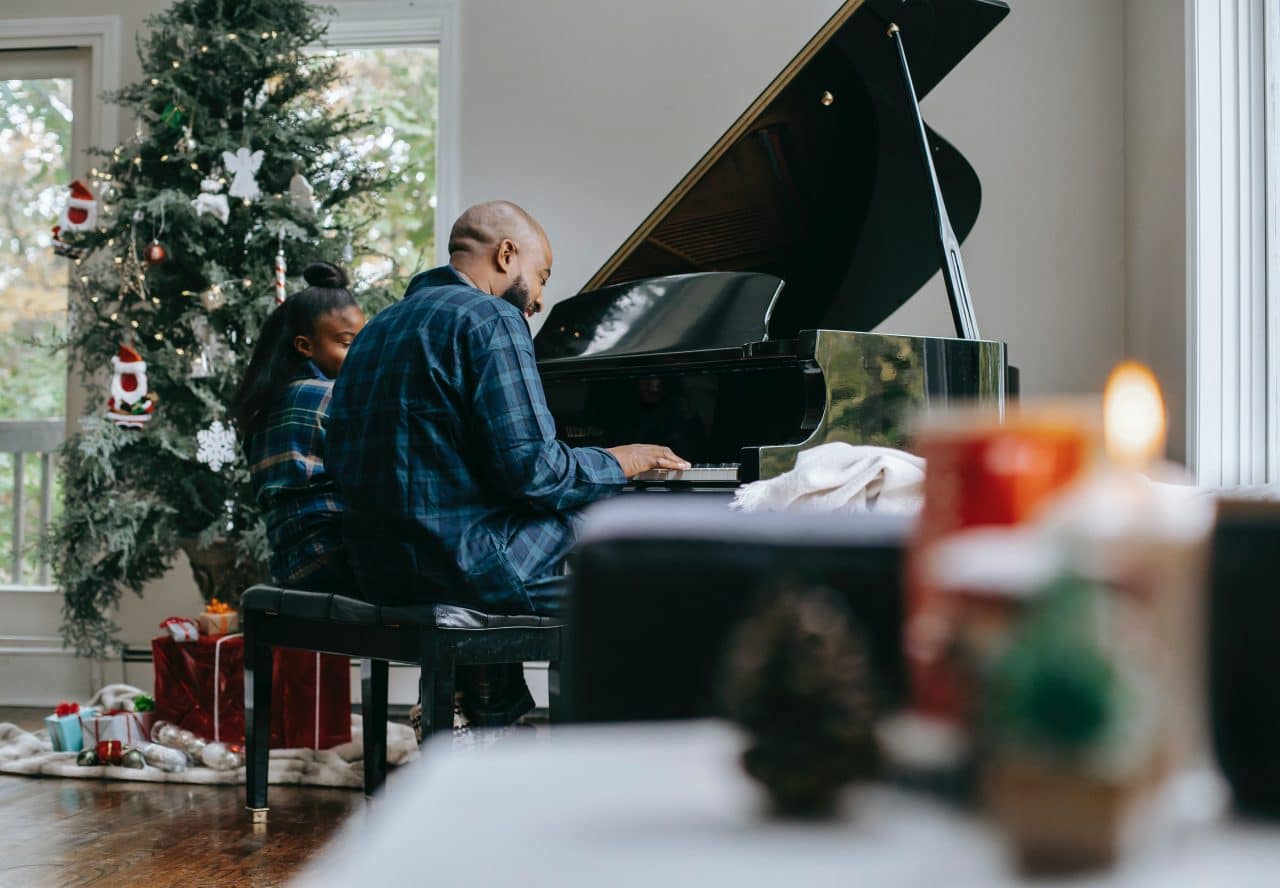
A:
[0,50,90,585]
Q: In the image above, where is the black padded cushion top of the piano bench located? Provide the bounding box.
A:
[241,586,564,630]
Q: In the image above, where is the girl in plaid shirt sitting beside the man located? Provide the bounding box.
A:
[232,262,365,596]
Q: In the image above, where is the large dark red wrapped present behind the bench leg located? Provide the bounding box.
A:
[151,635,351,750]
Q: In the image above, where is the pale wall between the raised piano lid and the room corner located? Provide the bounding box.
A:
[883,0,1125,404]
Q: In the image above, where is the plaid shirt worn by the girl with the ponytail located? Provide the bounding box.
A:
[244,361,342,586]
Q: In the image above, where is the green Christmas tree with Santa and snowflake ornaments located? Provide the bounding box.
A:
[47,0,390,655]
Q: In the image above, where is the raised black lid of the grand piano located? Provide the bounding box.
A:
[538,0,1009,358]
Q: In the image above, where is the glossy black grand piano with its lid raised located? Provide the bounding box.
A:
[535,0,1016,491]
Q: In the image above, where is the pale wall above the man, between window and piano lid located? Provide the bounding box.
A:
[460,0,840,322]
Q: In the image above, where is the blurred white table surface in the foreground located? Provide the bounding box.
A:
[301,722,1280,888]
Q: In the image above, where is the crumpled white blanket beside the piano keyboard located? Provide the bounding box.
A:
[732,443,924,514]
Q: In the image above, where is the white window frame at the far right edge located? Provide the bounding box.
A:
[1185,0,1280,486]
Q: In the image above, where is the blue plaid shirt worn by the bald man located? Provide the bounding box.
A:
[325,266,626,613]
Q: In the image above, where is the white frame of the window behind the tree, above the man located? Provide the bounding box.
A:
[324,0,461,265]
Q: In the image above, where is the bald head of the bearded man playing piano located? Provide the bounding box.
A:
[449,201,552,317]
